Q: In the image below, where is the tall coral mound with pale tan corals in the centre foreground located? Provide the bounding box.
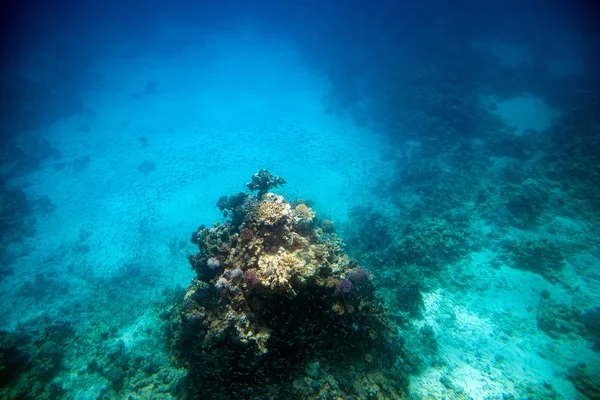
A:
[174,170,406,399]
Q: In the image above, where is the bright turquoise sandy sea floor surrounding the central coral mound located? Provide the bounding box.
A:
[0,29,600,399]
